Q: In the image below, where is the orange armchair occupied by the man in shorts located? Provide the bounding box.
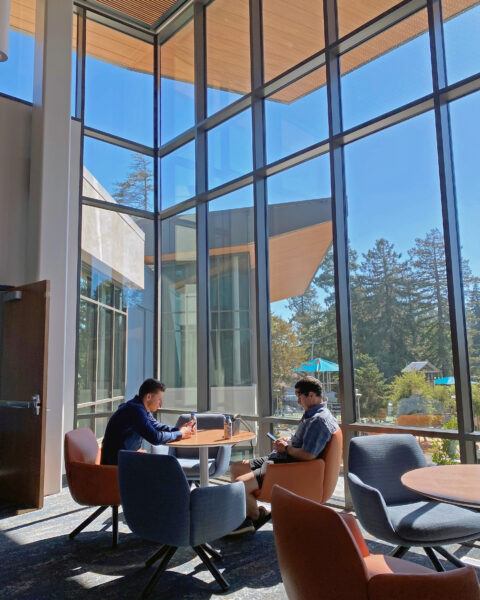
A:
[257,429,343,503]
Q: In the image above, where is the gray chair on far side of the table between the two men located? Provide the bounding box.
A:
[164,413,232,481]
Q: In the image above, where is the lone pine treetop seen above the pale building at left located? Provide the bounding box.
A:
[113,154,153,210]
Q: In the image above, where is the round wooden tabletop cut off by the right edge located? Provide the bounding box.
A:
[402,465,480,508]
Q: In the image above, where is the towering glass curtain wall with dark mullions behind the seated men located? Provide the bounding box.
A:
[73,0,480,474]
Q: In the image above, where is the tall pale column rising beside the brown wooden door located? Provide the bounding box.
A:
[27,0,78,494]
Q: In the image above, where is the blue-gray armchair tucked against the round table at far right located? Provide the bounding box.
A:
[348,434,480,571]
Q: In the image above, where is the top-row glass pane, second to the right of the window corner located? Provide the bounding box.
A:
[206,0,251,115]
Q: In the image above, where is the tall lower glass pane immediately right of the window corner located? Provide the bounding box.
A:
[160,211,197,411]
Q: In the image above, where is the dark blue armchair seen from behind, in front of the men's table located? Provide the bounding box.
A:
[118,450,245,598]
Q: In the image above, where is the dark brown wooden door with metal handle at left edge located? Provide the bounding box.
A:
[0,281,49,512]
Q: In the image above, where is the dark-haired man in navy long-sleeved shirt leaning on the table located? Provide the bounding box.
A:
[102,379,193,465]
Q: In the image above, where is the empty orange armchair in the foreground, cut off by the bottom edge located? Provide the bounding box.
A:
[272,486,480,600]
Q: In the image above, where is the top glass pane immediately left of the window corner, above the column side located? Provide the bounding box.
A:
[85,20,153,146]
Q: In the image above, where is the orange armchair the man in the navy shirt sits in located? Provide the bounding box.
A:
[65,428,120,548]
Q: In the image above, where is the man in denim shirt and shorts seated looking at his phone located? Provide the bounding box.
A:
[230,377,338,534]
